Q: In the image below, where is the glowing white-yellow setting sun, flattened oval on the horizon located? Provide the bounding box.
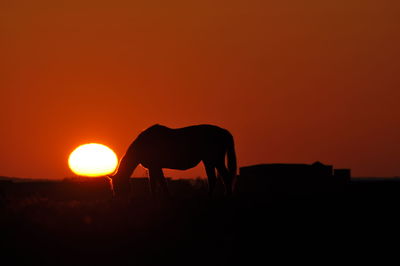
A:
[68,143,118,176]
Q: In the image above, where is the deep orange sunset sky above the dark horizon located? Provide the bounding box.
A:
[0,0,400,178]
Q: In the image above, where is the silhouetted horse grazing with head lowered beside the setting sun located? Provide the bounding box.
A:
[110,125,237,195]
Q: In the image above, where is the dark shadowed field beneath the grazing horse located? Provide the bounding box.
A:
[0,179,400,265]
